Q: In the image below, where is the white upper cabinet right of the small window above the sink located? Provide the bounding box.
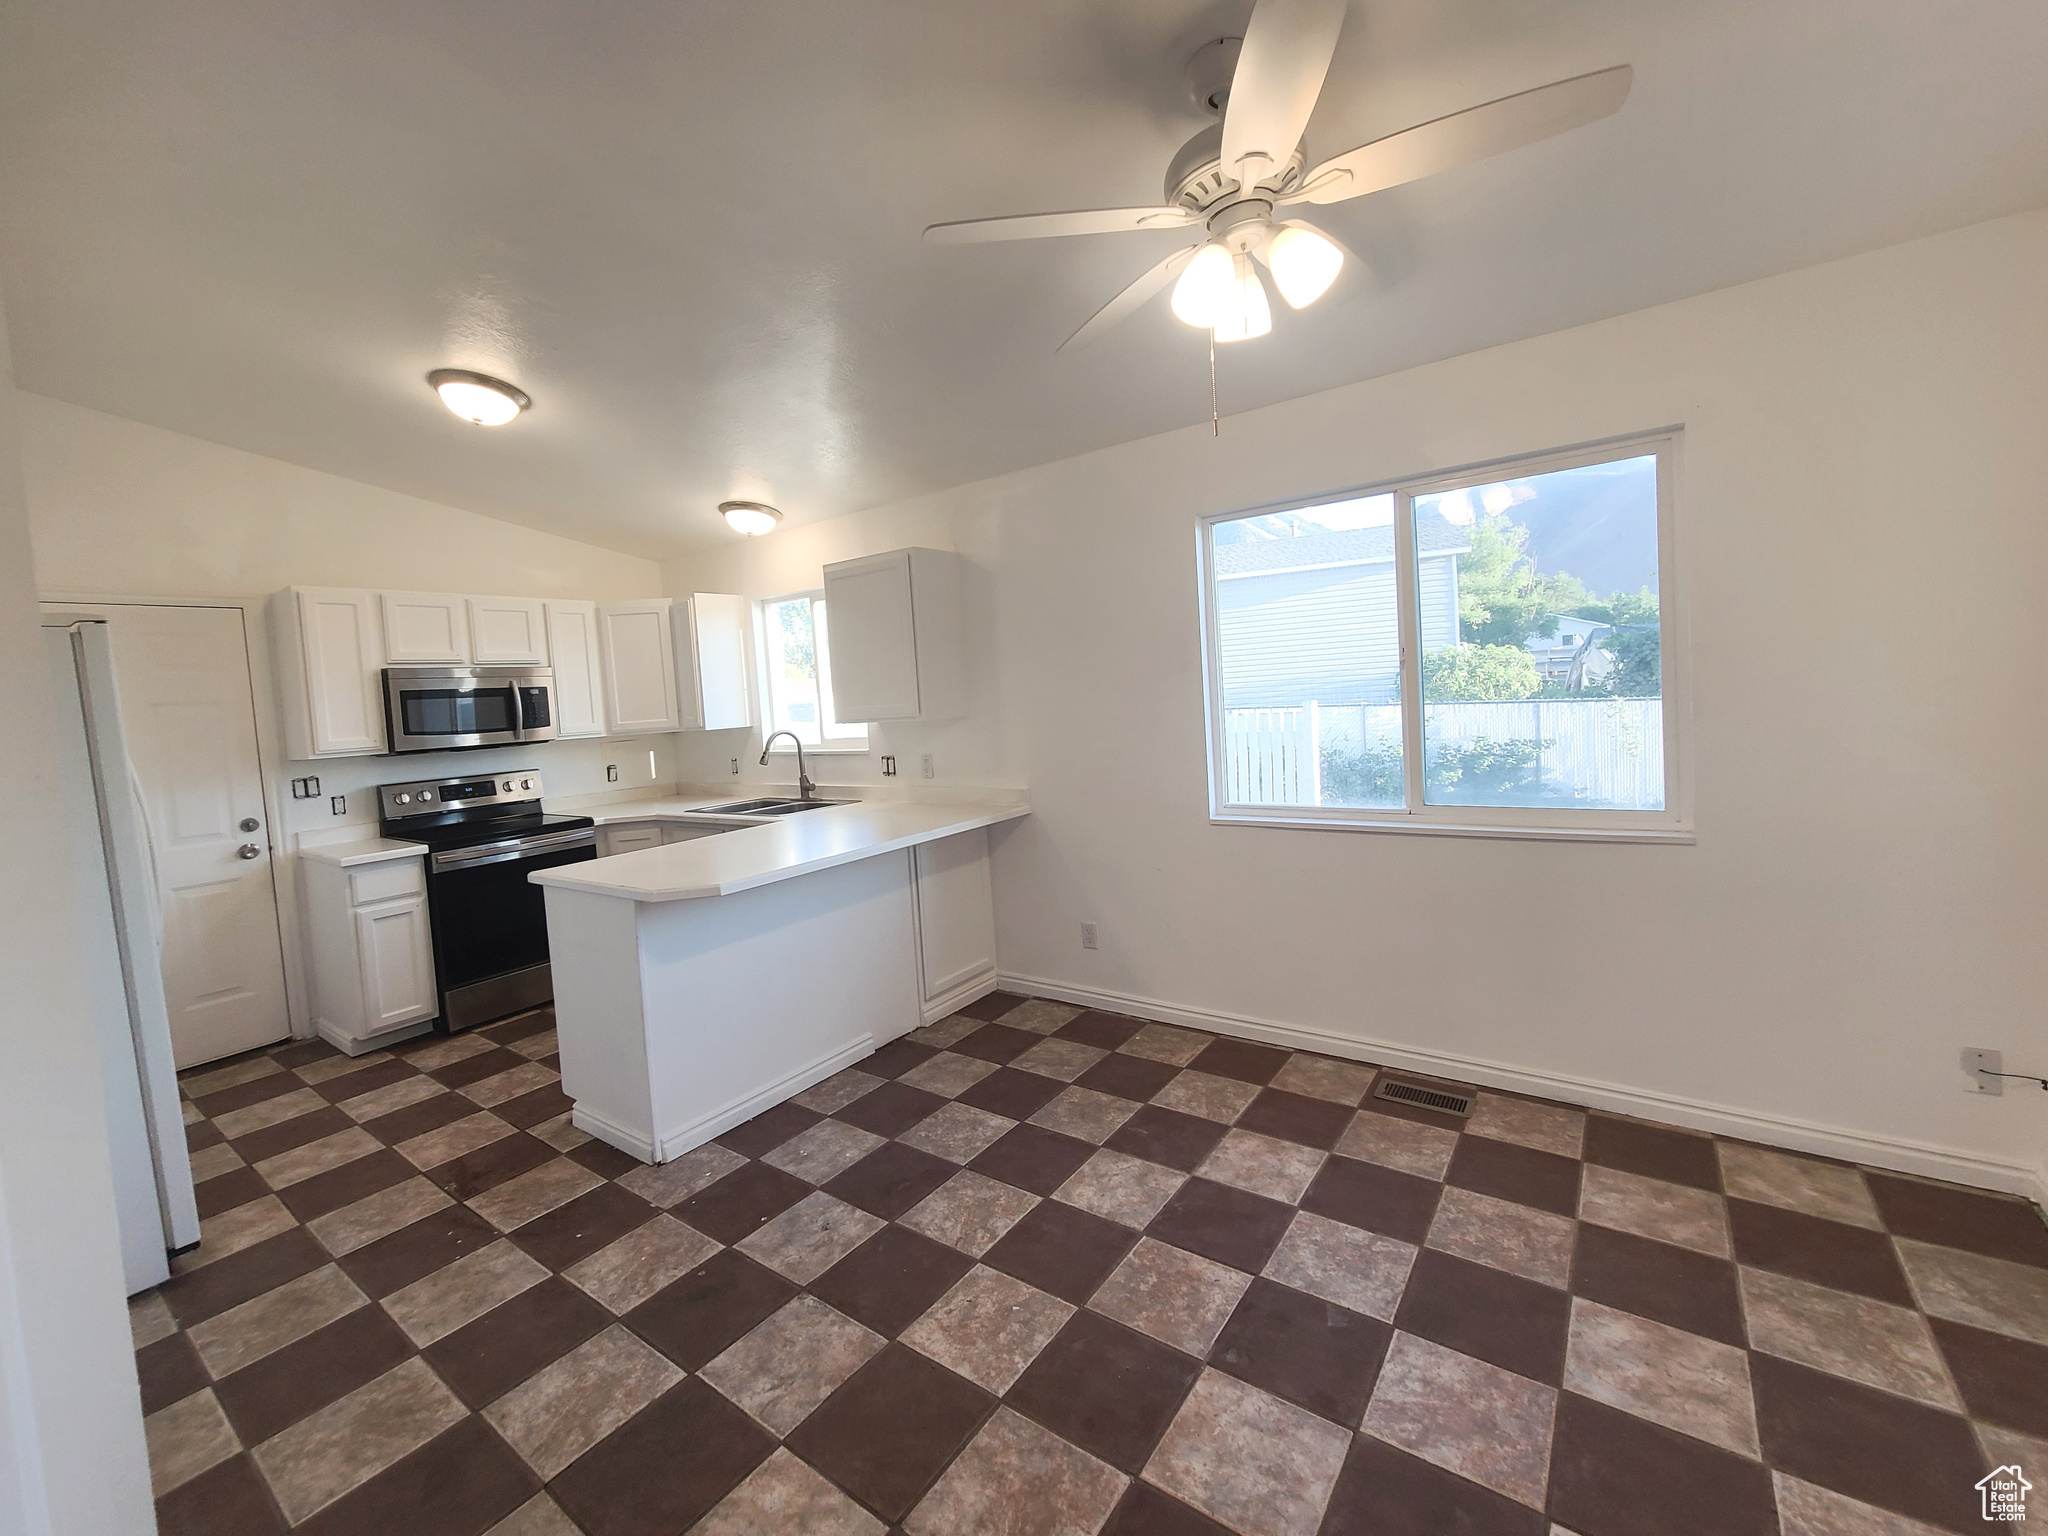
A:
[825,549,967,721]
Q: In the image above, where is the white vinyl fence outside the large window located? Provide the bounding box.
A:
[1223,698,1663,811]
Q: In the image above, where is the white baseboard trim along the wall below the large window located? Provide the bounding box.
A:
[999,971,2048,1208]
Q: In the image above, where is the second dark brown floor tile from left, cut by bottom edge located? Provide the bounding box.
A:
[293,1417,541,1536]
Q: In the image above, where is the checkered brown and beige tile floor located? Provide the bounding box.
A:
[133,993,2048,1536]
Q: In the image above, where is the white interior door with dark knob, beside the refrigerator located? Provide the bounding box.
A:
[104,604,291,1067]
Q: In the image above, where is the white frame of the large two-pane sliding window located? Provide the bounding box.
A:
[1194,428,1696,844]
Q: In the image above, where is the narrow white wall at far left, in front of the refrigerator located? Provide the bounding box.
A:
[0,296,156,1536]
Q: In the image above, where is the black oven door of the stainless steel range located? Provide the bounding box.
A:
[426,827,598,1030]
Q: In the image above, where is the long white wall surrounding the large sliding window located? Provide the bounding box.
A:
[664,213,2048,1194]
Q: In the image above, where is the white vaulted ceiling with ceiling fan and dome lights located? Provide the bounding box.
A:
[0,0,2048,557]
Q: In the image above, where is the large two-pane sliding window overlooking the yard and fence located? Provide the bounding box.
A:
[1202,436,1690,838]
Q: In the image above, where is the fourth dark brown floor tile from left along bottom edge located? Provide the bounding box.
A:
[782,1343,995,1536]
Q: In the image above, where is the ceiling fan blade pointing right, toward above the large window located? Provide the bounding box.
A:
[1280,63,1636,203]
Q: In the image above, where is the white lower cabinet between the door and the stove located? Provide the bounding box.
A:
[301,856,440,1053]
